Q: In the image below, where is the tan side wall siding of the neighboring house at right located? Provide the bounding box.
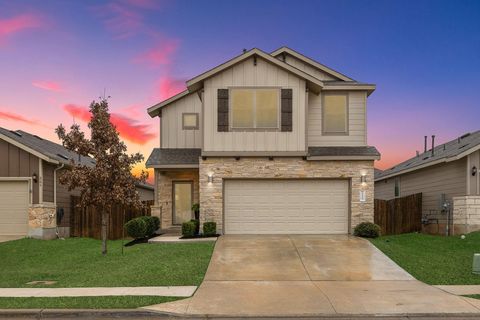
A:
[375,157,467,214]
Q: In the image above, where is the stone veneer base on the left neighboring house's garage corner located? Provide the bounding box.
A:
[28,203,57,239]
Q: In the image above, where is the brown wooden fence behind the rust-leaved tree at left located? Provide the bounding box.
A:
[70,196,153,240]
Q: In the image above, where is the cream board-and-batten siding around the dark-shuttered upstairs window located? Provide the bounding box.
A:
[203,57,306,152]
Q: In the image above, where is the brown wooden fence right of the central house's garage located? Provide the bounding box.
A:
[374,193,422,235]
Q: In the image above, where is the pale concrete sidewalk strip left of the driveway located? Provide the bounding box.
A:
[0,286,197,298]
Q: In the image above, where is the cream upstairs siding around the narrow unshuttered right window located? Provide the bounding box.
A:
[307,91,367,147]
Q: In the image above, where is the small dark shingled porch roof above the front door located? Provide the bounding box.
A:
[146,148,202,168]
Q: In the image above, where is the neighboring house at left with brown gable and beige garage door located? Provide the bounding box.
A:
[0,127,153,239]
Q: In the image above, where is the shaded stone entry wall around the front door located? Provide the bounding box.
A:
[152,169,199,229]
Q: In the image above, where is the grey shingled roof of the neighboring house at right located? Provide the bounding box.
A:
[375,130,480,181]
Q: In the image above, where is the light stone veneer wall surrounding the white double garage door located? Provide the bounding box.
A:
[199,157,374,233]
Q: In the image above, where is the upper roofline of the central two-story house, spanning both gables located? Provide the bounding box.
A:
[147,47,375,117]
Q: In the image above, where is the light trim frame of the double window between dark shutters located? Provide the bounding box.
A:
[228,87,282,131]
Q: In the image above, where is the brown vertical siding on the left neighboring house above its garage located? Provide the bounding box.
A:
[0,140,39,204]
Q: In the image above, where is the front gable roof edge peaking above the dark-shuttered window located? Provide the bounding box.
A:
[187,48,323,92]
